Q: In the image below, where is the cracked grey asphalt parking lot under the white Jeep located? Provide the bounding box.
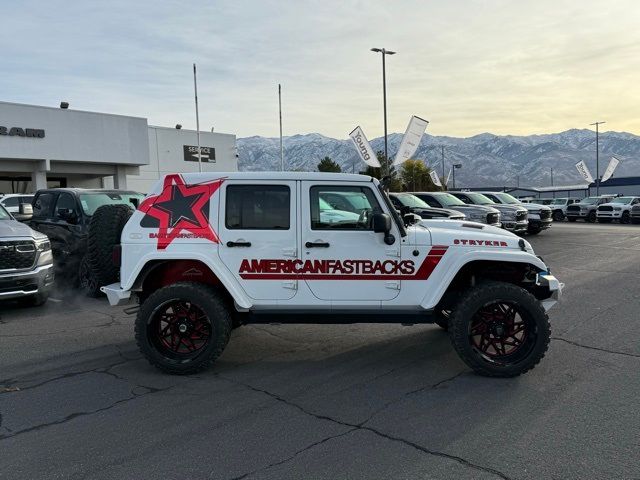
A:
[0,223,640,479]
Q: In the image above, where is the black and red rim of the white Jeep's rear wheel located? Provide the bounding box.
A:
[147,299,212,360]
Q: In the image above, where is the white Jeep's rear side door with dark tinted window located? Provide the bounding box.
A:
[218,180,299,300]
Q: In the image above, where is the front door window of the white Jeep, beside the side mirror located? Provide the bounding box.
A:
[309,185,382,230]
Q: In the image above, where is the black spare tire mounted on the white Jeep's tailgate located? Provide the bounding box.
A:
[87,205,133,286]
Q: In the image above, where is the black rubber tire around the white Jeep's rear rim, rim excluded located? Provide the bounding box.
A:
[135,282,232,375]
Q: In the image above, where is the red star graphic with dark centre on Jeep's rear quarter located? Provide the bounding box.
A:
[139,174,224,250]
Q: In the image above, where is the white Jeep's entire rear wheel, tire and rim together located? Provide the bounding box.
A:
[135,282,232,375]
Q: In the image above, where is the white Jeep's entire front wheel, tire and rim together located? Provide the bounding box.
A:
[449,282,551,377]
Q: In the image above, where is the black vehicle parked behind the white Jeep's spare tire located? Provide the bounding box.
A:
[27,188,144,295]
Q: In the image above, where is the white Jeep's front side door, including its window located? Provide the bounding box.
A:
[296,182,400,301]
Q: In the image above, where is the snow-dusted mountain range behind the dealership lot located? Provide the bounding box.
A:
[237,129,640,186]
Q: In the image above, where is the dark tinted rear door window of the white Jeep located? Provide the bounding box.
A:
[225,185,291,230]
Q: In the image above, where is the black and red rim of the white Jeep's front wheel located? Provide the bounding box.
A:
[469,300,537,365]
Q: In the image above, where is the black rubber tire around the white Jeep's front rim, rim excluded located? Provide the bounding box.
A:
[449,281,551,377]
